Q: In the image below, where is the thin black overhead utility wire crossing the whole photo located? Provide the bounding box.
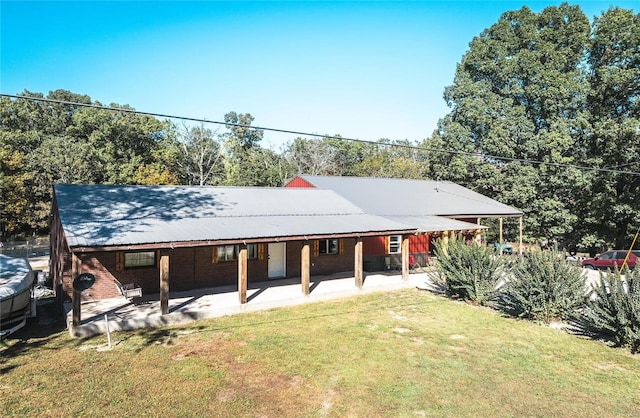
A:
[0,93,640,176]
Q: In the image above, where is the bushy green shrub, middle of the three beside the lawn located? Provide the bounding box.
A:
[503,251,586,324]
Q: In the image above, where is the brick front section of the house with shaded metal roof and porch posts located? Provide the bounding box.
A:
[50,184,417,325]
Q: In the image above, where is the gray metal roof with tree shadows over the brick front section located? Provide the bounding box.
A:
[54,184,416,247]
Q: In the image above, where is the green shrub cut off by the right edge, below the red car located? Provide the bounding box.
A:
[584,269,640,352]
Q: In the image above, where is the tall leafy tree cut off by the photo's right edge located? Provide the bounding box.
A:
[579,8,640,248]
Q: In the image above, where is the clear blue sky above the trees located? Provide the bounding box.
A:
[0,0,640,149]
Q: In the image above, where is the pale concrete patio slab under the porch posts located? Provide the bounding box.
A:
[65,271,427,337]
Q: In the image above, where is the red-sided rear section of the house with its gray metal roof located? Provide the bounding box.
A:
[285,175,522,271]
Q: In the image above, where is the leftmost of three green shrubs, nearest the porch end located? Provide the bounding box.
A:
[431,239,504,305]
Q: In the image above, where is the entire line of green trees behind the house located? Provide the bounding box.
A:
[0,3,640,255]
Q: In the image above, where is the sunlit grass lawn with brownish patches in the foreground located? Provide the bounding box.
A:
[0,290,640,417]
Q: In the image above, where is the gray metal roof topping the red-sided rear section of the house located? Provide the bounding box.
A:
[299,175,522,218]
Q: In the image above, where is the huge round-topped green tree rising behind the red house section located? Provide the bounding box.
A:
[426,4,590,243]
